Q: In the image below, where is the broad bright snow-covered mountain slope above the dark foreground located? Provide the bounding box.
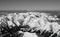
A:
[0,12,60,37]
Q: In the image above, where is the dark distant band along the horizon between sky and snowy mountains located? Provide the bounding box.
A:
[0,10,60,16]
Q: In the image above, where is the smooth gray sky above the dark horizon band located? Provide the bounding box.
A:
[0,0,60,10]
